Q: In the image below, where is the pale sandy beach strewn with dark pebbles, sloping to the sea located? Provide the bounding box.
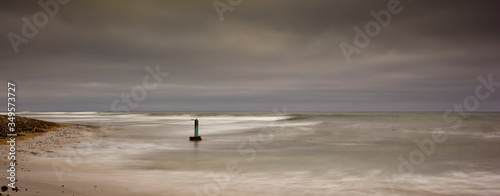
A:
[0,117,199,196]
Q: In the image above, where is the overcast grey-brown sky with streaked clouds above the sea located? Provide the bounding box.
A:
[0,0,500,111]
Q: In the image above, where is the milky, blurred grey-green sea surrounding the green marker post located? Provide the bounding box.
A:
[20,112,500,195]
